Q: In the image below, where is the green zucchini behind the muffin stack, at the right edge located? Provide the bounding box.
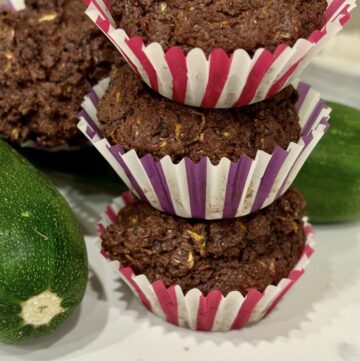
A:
[294,102,360,223]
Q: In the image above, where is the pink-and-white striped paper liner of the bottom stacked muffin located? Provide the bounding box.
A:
[97,192,315,331]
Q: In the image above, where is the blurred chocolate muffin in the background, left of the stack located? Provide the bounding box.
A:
[0,0,117,148]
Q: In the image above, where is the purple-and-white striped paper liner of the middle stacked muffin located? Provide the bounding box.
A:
[78,79,330,219]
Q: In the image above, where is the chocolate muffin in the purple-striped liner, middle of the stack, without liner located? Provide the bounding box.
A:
[98,64,300,164]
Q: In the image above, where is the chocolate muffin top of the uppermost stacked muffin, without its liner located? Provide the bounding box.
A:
[110,0,327,54]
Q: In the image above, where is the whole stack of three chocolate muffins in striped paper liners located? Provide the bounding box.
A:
[79,0,347,331]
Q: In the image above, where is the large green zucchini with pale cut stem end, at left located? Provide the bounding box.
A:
[0,140,88,343]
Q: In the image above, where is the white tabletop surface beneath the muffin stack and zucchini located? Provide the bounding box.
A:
[0,28,360,361]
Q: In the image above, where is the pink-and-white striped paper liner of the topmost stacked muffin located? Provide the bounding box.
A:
[84,0,356,108]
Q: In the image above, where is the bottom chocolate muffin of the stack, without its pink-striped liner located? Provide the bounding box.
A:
[102,190,306,295]
